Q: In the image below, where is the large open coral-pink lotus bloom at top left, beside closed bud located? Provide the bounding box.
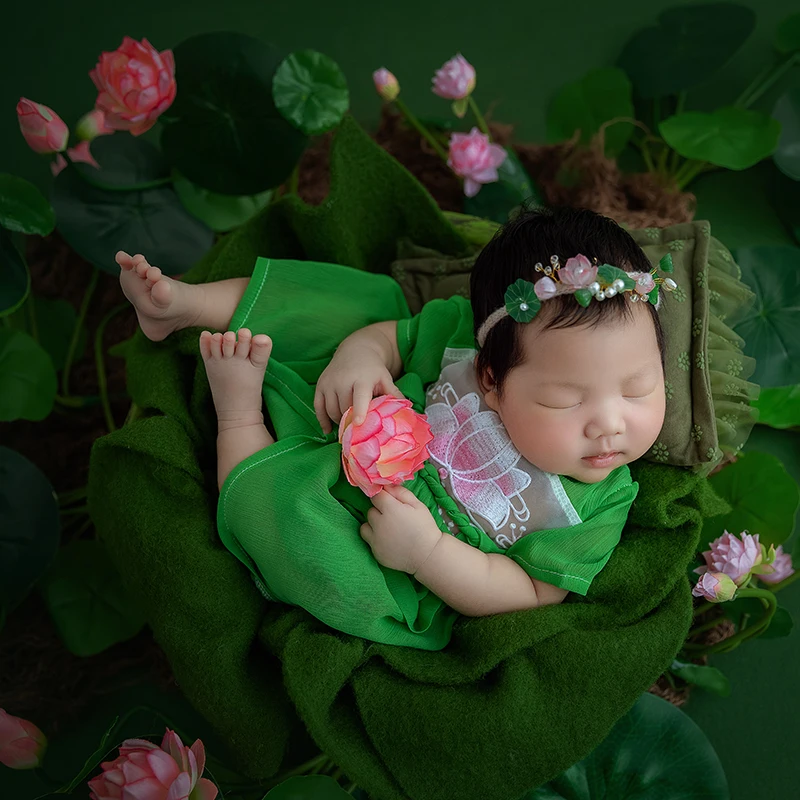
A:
[89,36,176,136]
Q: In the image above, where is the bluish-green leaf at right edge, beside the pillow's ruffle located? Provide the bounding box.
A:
[734,246,800,387]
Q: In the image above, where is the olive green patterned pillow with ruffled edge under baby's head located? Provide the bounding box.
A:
[392,222,758,472]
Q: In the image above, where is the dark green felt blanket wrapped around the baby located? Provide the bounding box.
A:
[89,115,723,800]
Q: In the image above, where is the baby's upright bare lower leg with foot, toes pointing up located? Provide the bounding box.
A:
[200,328,275,489]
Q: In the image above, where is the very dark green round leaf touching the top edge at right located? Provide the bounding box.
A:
[617,3,756,98]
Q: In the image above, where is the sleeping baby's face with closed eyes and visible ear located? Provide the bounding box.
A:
[485,303,666,483]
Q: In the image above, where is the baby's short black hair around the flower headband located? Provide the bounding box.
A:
[470,208,664,395]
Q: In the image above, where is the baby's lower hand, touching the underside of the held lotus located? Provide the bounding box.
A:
[361,486,444,575]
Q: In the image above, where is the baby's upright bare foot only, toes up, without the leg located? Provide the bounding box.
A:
[200,328,272,428]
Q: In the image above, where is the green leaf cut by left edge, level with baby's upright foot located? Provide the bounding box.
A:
[0,330,58,422]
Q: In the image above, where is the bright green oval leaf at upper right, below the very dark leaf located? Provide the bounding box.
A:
[658,106,781,169]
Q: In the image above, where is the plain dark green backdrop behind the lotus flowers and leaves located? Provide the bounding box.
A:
[0,0,800,800]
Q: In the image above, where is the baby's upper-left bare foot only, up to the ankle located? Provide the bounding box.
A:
[116,250,208,342]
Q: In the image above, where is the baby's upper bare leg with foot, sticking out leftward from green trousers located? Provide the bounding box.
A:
[117,250,248,342]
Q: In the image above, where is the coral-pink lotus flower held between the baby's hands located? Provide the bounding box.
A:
[339,394,433,497]
